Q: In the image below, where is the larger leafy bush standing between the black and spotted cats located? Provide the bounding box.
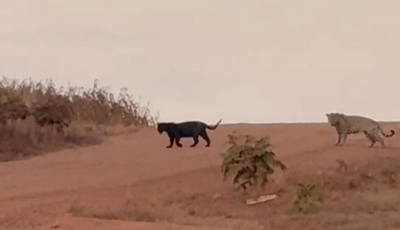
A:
[221,134,286,190]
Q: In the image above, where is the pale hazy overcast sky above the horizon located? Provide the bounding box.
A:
[0,0,400,123]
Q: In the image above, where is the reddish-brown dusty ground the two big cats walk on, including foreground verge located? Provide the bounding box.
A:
[0,124,400,230]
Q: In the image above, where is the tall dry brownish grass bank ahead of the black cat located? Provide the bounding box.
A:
[0,78,155,161]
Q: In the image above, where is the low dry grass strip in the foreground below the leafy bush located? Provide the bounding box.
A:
[70,156,400,230]
